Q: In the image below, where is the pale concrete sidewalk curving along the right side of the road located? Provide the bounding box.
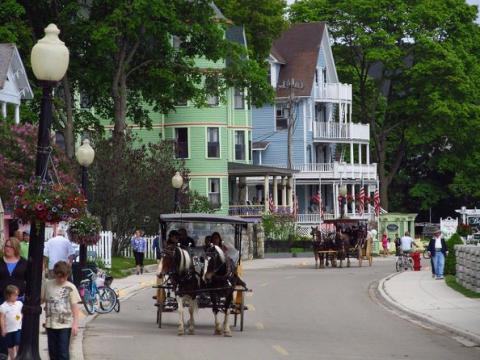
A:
[378,269,480,346]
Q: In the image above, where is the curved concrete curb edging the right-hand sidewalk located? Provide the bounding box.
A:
[375,273,480,346]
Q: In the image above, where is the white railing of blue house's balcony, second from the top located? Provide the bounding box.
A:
[313,121,370,141]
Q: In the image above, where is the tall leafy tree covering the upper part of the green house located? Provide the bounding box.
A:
[74,0,270,138]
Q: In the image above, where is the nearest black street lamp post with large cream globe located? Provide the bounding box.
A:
[17,24,69,360]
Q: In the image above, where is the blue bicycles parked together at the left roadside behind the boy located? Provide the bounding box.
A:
[79,268,120,314]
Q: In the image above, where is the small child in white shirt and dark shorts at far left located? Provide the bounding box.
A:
[0,285,23,360]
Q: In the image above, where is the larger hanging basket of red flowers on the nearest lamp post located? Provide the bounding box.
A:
[12,177,86,223]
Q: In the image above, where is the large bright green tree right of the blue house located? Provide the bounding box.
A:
[290,0,479,212]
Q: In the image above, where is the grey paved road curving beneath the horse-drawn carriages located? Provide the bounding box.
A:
[84,261,480,360]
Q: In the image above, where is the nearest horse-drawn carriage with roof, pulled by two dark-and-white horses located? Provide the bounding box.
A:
[154,214,251,336]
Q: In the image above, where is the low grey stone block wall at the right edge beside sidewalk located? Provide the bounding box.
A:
[455,245,480,293]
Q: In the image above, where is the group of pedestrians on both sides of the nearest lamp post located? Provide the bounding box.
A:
[0,229,81,360]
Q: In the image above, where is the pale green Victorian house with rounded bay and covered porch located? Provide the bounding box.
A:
[117,26,292,216]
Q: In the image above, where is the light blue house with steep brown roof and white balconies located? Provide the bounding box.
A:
[247,22,378,224]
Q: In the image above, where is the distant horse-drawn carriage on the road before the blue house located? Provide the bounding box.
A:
[311,219,372,268]
